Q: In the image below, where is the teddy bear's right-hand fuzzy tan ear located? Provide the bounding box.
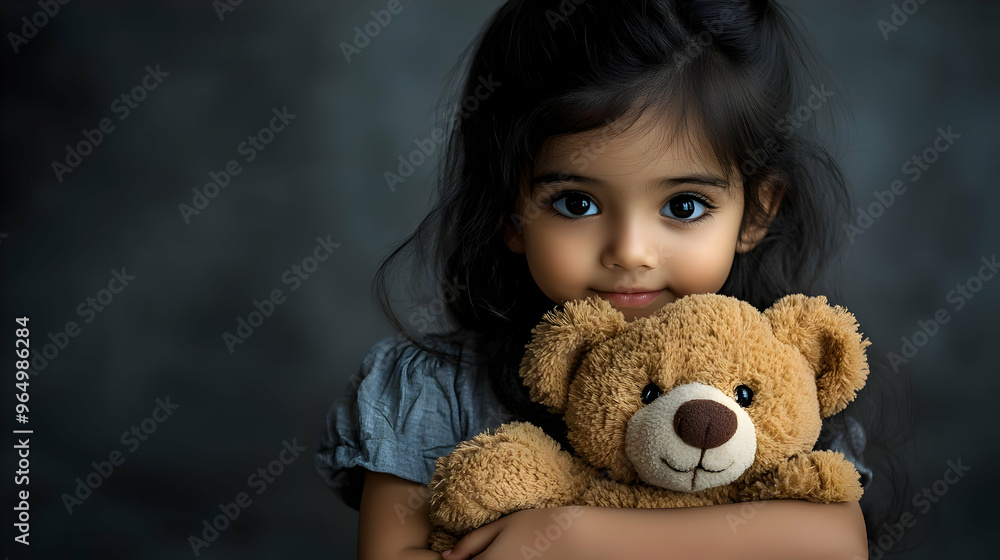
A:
[764,294,871,418]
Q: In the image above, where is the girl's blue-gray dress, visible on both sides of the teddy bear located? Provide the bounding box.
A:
[315,334,871,509]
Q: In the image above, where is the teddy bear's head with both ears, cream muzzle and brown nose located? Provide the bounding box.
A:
[521,294,869,492]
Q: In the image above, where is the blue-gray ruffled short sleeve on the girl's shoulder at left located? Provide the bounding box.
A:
[315,335,464,509]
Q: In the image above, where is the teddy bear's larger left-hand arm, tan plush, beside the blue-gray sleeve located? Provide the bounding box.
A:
[430,422,595,535]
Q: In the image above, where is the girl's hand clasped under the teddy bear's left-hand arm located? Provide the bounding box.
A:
[442,506,597,560]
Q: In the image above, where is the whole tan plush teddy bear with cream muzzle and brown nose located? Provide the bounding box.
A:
[429,294,870,552]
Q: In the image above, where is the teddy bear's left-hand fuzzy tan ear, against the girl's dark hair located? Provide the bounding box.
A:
[520,296,628,414]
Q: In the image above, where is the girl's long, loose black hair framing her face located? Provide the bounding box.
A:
[375,0,912,544]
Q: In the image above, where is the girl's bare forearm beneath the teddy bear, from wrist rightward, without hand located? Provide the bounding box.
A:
[583,500,868,560]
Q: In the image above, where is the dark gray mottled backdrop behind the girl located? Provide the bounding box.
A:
[0,0,1000,558]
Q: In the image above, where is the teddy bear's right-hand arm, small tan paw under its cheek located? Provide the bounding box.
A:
[741,451,862,503]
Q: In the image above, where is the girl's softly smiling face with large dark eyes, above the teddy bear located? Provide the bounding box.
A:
[505,116,765,321]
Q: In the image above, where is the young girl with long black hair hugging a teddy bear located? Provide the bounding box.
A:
[317,0,900,560]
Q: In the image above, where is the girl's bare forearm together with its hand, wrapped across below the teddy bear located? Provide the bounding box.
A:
[446,500,868,560]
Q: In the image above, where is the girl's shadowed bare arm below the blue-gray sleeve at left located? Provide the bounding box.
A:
[358,471,441,560]
